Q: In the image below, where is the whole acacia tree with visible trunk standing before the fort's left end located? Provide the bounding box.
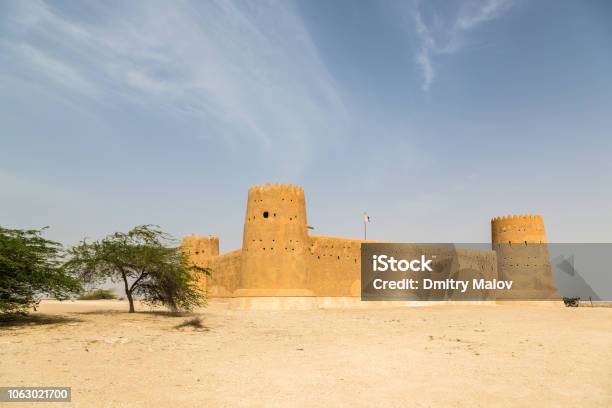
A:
[65,225,210,313]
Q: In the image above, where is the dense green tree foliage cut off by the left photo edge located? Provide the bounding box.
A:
[0,227,81,313]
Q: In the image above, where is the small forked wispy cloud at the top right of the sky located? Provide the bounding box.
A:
[412,0,514,91]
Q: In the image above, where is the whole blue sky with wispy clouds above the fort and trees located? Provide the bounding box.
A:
[0,0,612,251]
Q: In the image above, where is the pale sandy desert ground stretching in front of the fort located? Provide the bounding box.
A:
[0,301,612,407]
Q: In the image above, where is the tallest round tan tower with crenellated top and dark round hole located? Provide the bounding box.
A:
[236,183,311,296]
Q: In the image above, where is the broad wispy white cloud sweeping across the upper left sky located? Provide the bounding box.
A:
[0,0,347,172]
